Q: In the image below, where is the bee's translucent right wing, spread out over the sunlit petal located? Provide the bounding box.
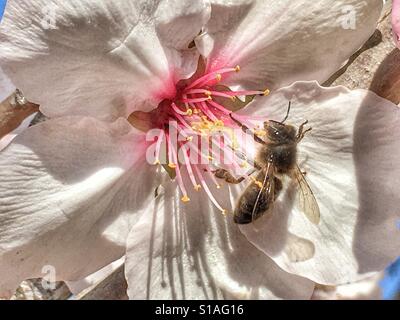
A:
[292,165,320,224]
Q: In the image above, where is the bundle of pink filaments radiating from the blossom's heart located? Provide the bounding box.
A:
[156,63,264,212]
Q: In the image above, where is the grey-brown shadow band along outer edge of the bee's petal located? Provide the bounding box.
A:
[353,93,400,273]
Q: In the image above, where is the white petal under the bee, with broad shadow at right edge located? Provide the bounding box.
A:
[234,82,400,285]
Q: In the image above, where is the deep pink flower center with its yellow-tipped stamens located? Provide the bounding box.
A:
[134,66,269,214]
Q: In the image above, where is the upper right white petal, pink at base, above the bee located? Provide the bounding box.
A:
[197,0,382,89]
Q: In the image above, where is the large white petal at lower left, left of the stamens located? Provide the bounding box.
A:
[0,117,156,296]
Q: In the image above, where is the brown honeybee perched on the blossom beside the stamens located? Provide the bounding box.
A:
[214,102,320,224]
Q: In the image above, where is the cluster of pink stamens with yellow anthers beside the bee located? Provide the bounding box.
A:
[147,62,269,215]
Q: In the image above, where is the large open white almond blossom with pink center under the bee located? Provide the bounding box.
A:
[0,0,400,299]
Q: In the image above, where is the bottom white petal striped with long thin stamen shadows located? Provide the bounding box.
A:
[125,183,314,299]
